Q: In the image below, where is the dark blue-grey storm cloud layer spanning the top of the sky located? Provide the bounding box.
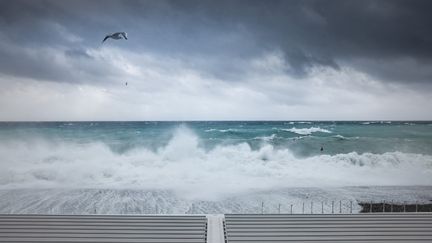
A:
[0,0,432,83]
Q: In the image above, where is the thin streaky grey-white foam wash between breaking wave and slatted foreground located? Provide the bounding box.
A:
[0,186,432,214]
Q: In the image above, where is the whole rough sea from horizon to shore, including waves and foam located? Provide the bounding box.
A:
[0,121,432,214]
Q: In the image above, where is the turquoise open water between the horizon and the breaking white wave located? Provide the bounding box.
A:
[0,121,432,157]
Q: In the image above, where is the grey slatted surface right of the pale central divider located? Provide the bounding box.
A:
[225,213,432,243]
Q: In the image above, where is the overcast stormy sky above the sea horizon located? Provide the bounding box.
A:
[0,0,432,121]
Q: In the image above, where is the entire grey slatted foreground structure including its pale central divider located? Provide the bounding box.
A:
[0,213,432,243]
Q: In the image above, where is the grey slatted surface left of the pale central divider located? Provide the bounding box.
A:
[0,215,207,243]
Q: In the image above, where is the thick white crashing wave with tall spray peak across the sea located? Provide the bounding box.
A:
[0,127,432,198]
